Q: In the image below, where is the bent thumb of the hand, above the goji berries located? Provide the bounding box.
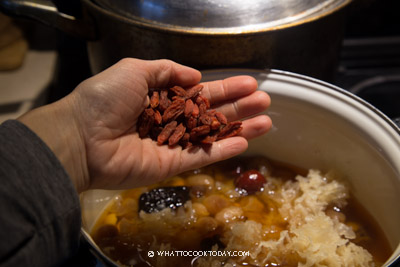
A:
[127,59,201,88]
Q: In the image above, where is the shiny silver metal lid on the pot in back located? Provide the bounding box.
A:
[93,0,351,33]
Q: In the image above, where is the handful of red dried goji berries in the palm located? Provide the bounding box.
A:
[138,84,242,148]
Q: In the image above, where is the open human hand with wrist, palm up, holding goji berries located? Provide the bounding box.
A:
[17,59,271,192]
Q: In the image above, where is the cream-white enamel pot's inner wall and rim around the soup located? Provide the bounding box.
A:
[81,69,400,266]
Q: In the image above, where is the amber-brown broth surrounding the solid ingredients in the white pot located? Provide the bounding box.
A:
[92,157,392,266]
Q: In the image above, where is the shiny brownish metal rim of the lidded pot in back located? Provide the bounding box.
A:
[82,0,352,36]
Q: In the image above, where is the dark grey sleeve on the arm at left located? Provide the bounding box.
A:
[0,121,81,267]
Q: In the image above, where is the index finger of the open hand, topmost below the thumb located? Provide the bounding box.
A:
[201,76,258,105]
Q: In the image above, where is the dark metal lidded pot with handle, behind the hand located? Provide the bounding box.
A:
[1,0,351,80]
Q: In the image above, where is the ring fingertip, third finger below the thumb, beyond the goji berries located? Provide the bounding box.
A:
[239,115,272,140]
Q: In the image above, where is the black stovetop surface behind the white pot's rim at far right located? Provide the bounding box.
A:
[333,36,400,122]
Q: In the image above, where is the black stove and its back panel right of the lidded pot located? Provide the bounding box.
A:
[333,0,400,125]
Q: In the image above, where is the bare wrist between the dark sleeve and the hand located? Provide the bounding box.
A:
[18,97,88,193]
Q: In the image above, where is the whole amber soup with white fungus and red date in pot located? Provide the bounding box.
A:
[92,156,392,266]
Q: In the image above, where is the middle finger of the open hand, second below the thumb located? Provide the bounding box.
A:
[216,91,271,121]
